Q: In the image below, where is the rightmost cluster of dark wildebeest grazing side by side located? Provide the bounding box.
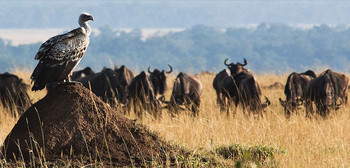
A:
[280,69,349,117]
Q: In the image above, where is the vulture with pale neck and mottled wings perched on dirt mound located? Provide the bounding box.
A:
[30,13,94,91]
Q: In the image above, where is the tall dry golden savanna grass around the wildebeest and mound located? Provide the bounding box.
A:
[0,70,350,167]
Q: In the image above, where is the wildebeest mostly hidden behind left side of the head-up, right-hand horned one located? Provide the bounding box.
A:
[213,69,230,109]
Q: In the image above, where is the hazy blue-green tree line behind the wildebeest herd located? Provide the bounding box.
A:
[0,23,350,73]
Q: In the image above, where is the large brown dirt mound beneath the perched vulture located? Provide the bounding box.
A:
[1,85,186,166]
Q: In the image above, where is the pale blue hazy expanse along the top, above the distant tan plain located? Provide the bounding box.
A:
[0,0,350,28]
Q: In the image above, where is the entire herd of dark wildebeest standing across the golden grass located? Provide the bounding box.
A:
[0,59,349,118]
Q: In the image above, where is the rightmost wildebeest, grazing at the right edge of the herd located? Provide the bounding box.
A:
[307,69,349,117]
